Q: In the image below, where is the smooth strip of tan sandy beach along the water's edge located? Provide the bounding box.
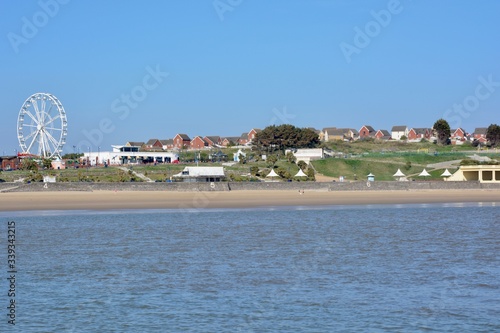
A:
[0,190,500,211]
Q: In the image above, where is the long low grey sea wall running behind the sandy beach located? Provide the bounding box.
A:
[0,181,500,192]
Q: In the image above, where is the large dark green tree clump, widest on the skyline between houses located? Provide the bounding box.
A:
[252,124,320,153]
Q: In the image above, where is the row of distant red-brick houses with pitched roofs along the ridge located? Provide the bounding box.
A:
[118,125,487,150]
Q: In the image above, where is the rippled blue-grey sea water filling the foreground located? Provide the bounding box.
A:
[0,204,500,332]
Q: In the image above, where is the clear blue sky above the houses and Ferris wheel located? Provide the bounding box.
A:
[0,0,500,154]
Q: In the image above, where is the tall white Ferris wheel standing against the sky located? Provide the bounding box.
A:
[17,93,68,158]
